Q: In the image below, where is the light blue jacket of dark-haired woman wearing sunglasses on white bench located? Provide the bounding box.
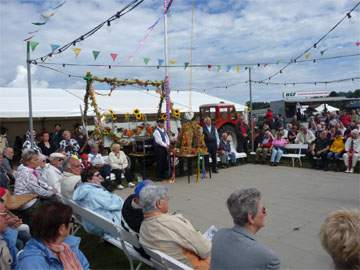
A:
[73,183,124,235]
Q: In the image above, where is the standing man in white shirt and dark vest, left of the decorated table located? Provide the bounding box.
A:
[153,119,170,180]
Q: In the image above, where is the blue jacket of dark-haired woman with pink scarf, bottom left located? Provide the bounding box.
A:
[16,236,90,270]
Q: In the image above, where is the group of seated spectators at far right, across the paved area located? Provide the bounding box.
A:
[254,108,360,173]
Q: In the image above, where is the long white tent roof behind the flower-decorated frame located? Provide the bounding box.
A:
[0,87,246,118]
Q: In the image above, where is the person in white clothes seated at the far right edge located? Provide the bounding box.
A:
[344,129,360,173]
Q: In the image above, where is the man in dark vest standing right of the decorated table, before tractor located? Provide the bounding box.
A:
[203,117,220,173]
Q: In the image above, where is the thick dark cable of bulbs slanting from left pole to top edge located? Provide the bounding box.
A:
[30,0,144,64]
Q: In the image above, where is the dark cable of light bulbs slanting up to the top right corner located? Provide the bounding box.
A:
[261,2,360,82]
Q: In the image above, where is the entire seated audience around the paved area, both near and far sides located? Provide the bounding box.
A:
[0,111,360,270]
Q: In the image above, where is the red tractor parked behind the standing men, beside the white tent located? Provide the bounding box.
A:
[200,102,245,150]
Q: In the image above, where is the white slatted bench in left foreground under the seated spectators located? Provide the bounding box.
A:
[63,199,192,270]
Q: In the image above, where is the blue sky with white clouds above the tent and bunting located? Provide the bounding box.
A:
[0,0,360,103]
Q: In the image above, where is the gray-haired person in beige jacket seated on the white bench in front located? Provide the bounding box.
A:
[140,185,211,269]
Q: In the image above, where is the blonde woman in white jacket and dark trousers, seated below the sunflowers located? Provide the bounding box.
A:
[109,143,135,189]
